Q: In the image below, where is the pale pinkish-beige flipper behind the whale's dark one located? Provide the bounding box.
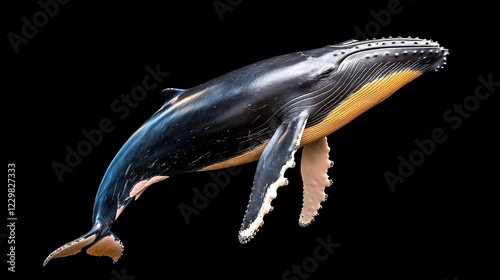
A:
[299,137,333,226]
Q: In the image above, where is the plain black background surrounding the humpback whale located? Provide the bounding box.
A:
[0,0,500,280]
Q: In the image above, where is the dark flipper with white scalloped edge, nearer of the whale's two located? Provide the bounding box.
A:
[239,113,308,243]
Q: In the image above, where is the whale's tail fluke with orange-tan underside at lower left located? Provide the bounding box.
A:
[43,224,123,266]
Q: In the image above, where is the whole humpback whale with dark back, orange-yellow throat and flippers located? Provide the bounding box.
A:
[44,37,448,265]
